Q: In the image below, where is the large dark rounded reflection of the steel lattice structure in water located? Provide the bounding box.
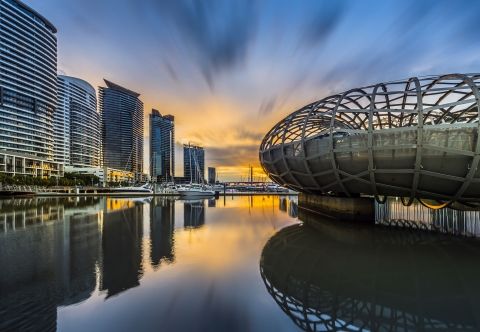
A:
[260,213,480,331]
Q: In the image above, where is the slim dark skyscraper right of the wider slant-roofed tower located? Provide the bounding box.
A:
[150,109,175,181]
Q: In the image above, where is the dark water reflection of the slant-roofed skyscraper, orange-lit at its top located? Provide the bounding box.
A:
[100,198,143,298]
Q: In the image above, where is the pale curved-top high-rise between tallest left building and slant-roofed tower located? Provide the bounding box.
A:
[54,76,101,167]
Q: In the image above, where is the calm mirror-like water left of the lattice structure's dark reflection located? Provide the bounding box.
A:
[0,196,296,331]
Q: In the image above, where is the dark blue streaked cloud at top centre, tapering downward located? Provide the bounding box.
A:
[151,0,257,88]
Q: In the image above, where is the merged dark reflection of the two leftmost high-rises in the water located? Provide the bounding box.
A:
[0,198,101,331]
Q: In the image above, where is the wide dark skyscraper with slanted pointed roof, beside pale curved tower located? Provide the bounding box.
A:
[99,80,143,179]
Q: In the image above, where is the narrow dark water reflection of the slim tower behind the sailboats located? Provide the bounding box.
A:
[150,197,175,268]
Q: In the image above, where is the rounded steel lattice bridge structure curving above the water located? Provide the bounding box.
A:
[260,74,480,205]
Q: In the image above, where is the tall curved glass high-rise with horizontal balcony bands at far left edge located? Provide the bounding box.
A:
[0,0,63,177]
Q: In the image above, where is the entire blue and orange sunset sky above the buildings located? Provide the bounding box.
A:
[25,0,480,180]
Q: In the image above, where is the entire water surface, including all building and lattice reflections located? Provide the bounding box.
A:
[0,196,480,331]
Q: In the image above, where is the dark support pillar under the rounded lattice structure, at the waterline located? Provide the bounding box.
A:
[298,194,375,223]
